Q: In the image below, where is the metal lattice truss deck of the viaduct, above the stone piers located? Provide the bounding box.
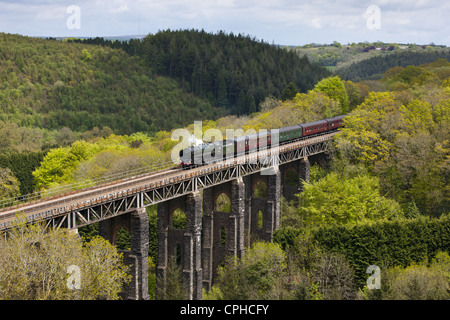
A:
[0,132,337,230]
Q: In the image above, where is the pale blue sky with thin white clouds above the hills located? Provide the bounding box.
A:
[0,0,450,46]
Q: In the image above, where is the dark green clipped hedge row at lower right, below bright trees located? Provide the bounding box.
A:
[274,217,450,284]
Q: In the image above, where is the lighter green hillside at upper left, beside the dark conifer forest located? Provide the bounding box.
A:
[0,34,218,134]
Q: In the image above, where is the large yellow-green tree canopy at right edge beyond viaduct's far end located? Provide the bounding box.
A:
[334,88,450,215]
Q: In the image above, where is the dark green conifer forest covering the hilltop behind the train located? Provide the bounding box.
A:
[78,30,330,115]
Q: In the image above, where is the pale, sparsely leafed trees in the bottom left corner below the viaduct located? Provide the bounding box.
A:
[0,225,130,300]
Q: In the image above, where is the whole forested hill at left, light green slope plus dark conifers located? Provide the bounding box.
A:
[0,30,329,134]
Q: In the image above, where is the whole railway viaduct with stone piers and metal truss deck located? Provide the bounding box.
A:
[0,132,336,300]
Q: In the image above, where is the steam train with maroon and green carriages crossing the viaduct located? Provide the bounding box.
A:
[179,115,345,168]
